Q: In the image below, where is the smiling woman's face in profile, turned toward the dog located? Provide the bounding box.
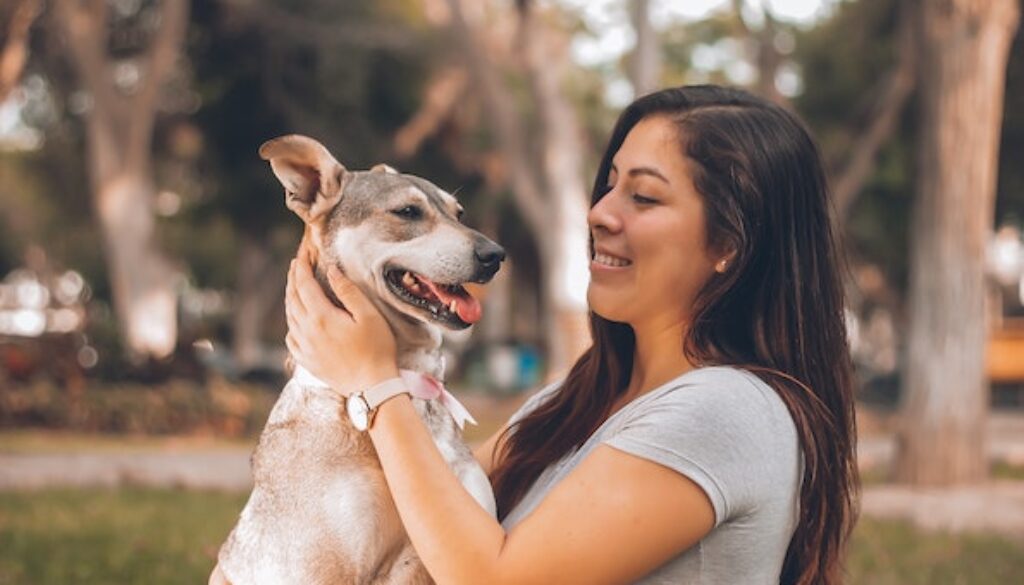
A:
[587,116,721,328]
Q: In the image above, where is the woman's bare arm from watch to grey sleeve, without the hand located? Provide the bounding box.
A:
[370,396,715,584]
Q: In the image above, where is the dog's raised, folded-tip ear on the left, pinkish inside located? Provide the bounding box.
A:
[259,134,349,223]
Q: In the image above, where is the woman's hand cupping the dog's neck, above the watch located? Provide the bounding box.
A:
[285,246,398,396]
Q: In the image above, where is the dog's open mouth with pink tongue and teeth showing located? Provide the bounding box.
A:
[384,268,483,329]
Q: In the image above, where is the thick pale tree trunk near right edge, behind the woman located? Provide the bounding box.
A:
[897,0,1020,486]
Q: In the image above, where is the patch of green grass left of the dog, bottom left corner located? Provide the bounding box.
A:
[0,489,245,585]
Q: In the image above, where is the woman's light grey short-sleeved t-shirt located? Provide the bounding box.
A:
[502,367,803,585]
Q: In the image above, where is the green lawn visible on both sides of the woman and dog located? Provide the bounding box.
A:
[0,489,1024,585]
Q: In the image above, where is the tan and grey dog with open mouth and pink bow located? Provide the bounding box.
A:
[211,134,505,585]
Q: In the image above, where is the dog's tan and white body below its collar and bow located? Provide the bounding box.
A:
[221,372,493,584]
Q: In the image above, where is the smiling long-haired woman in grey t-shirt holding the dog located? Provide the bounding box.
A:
[278,86,857,584]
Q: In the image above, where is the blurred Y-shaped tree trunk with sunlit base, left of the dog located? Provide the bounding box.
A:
[53,0,188,359]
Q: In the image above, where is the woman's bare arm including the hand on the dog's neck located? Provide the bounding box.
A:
[288,261,715,585]
